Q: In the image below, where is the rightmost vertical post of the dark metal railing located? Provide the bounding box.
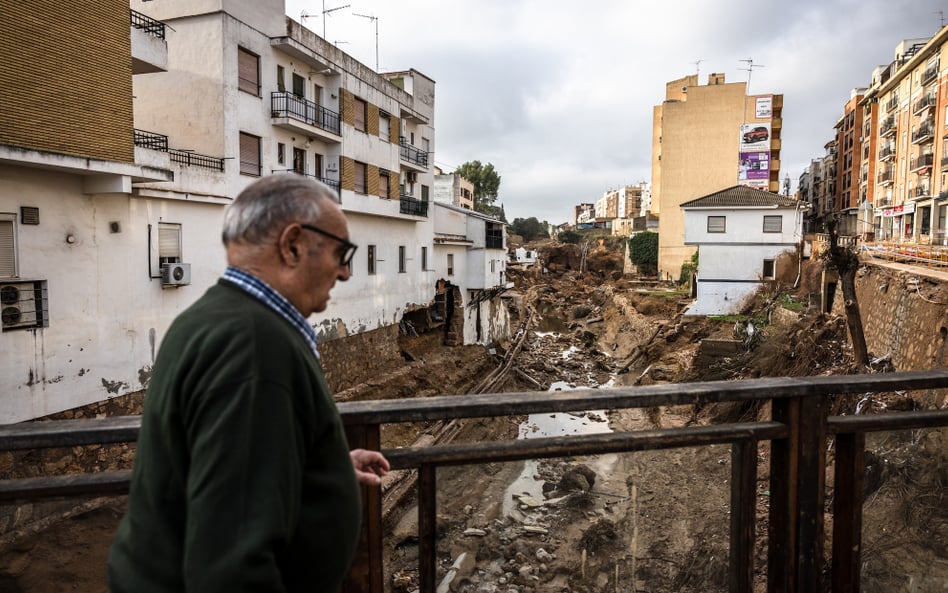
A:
[832,433,866,593]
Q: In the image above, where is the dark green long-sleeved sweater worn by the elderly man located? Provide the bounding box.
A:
[108,280,361,593]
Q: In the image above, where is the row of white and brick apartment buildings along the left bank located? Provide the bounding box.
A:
[0,0,507,423]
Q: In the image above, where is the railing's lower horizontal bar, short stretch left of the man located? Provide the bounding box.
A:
[0,470,132,501]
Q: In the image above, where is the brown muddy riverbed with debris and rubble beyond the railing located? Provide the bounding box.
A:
[0,237,948,593]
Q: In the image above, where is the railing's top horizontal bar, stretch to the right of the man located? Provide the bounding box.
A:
[338,370,948,424]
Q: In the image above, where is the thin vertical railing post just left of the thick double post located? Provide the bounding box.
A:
[728,440,757,593]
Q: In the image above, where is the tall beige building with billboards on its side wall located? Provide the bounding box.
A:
[652,73,783,279]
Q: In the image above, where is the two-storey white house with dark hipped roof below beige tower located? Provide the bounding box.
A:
[681,186,803,315]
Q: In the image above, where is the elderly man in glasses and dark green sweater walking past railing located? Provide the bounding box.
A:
[108,175,389,593]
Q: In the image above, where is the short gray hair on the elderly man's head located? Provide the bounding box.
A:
[221,173,338,245]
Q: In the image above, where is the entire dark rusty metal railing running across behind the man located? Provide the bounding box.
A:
[0,370,948,593]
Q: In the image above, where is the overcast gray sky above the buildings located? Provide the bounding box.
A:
[286,0,948,223]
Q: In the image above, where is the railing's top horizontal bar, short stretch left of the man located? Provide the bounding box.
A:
[0,416,141,451]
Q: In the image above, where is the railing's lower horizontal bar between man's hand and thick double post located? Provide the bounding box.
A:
[383,422,790,469]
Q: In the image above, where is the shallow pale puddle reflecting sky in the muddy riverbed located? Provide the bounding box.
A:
[503,380,618,516]
